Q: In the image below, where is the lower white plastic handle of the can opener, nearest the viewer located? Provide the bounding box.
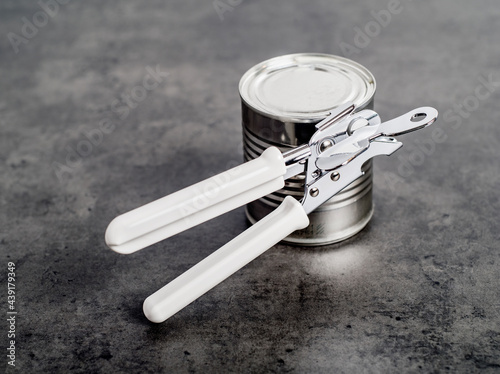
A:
[143,196,309,323]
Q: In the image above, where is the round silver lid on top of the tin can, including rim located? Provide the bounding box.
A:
[239,53,376,122]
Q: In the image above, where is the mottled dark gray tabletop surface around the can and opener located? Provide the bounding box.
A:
[0,0,500,373]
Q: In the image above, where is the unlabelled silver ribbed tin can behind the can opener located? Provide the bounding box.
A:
[239,53,376,246]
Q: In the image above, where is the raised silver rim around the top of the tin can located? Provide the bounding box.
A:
[239,53,377,123]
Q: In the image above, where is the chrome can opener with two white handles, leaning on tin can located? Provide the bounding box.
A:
[105,103,438,323]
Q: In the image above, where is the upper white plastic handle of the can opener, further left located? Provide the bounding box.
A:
[105,147,286,254]
